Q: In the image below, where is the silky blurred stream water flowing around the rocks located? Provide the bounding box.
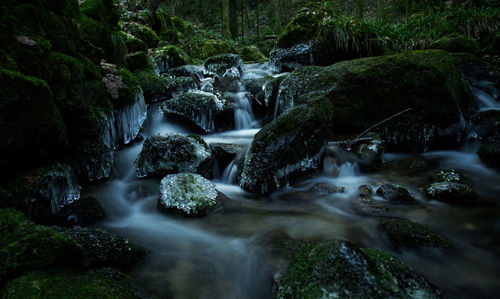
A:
[83,64,500,299]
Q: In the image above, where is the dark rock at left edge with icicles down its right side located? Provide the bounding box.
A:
[0,164,81,223]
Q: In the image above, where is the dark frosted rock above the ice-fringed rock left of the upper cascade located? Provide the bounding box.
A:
[134,69,196,103]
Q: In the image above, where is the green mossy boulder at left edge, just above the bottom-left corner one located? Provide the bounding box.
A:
[0,209,82,285]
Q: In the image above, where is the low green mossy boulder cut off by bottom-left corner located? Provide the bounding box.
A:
[2,268,143,299]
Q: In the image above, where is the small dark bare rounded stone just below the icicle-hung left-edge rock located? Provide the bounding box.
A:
[59,197,105,226]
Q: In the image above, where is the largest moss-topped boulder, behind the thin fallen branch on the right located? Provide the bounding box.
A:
[270,50,474,151]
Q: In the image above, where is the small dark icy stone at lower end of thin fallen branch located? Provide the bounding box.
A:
[353,139,384,171]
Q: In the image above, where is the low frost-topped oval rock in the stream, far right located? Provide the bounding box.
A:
[424,182,479,204]
